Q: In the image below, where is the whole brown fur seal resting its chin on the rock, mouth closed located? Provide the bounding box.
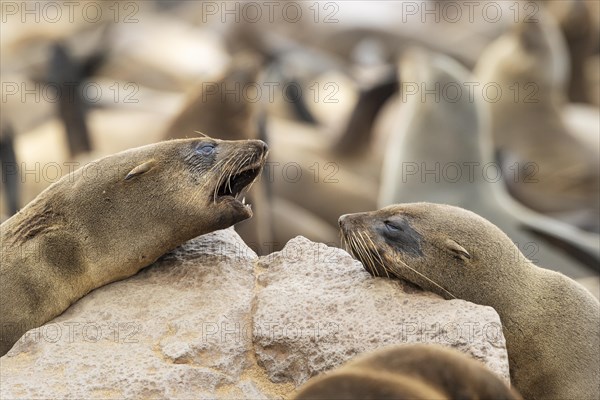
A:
[339,203,600,399]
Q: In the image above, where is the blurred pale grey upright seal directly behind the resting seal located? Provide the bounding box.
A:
[378,51,600,278]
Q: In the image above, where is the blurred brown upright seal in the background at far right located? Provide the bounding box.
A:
[475,9,600,233]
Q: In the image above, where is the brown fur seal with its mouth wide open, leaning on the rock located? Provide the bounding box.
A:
[0,138,267,355]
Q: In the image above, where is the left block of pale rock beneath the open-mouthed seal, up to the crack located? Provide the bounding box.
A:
[0,230,288,398]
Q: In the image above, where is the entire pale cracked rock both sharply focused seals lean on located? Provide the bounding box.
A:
[0,229,508,399]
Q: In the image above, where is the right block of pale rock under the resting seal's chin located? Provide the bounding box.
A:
[254,237,509,386]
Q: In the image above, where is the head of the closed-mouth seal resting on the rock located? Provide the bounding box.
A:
[339,203,502,299]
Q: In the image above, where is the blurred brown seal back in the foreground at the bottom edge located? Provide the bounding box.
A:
[295,344,521,400]
